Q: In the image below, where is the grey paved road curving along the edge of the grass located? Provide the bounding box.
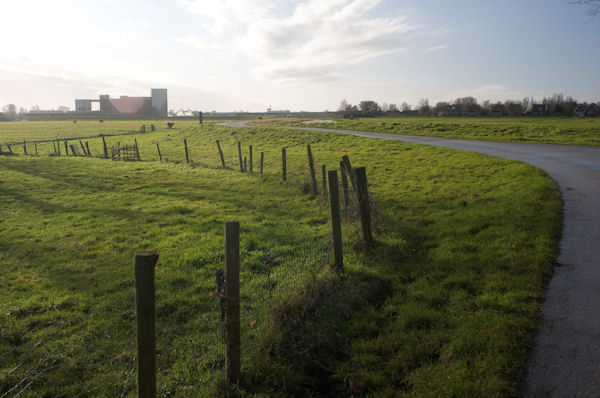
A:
[223,121,600,398]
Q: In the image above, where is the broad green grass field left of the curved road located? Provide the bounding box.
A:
[0,119,564,397]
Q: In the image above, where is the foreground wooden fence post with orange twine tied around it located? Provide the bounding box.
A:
[224,221,241,385]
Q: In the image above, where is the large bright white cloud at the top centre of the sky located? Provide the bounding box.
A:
[177,0,423,83]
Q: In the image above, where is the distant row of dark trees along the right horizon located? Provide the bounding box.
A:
[337,94,600,118]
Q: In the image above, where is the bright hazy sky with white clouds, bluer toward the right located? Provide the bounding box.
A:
[0,0,600,112]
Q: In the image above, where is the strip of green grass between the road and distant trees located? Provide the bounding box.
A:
[254,117,600,145]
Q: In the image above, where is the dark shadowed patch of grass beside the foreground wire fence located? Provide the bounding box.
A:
[241,271,392,397]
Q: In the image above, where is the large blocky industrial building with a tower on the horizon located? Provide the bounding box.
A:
[75,88,168,118]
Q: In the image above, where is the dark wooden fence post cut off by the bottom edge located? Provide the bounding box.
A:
[135,252,158,398]
